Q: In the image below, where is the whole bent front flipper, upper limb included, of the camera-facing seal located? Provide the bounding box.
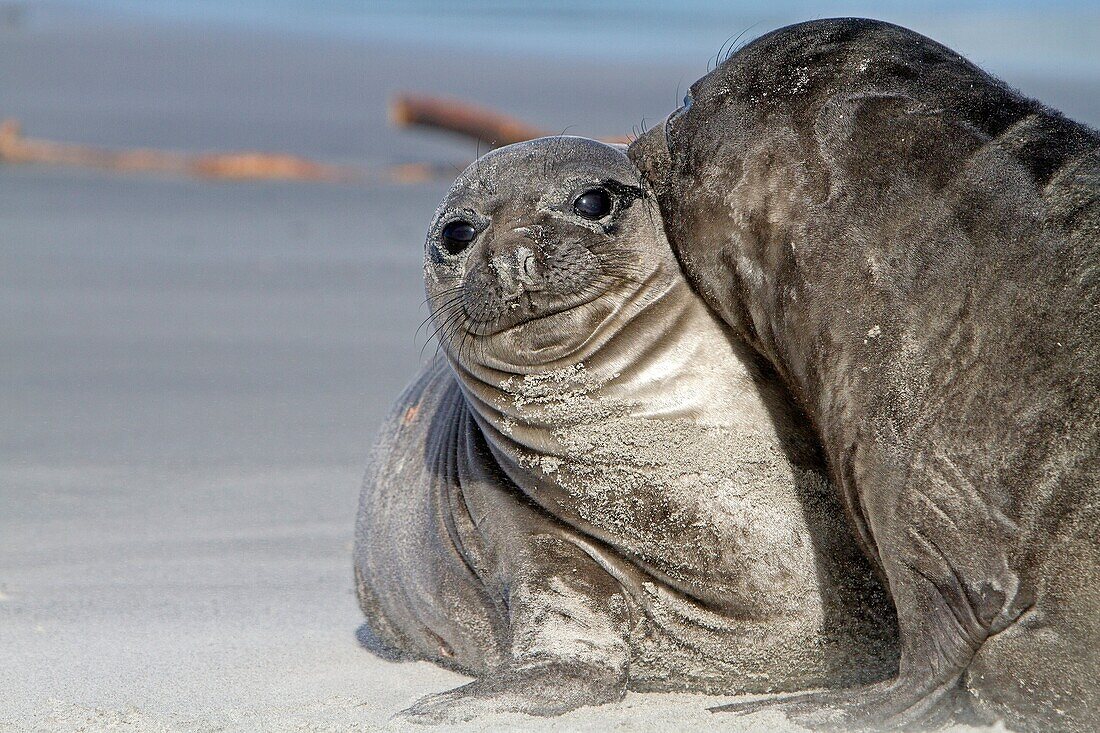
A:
[399,533,630,723]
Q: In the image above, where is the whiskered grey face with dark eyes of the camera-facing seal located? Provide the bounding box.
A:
[425,136,674,365]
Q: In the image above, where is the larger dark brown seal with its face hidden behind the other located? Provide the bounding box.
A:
[629,19,1100,731]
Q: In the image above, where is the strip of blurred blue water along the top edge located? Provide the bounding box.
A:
[38,0,1100,78]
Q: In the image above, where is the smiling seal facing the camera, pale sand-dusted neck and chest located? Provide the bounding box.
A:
[355,138,897,721]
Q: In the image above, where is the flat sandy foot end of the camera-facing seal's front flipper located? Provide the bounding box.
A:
[397,659,626,724]
